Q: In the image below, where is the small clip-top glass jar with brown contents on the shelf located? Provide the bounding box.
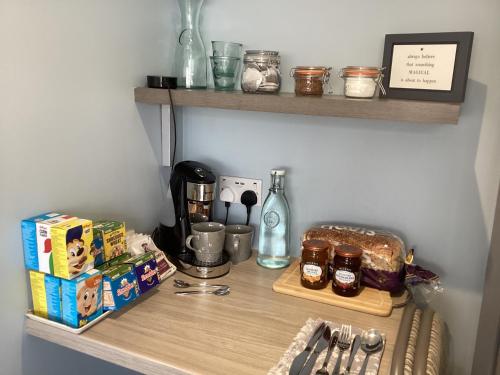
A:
[290,66,332,96]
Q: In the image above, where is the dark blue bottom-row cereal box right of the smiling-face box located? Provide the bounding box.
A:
[102,264,139,311]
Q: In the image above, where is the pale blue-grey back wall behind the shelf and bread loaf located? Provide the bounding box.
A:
[183,0,500,375]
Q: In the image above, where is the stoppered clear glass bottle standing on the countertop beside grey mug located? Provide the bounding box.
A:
[257,169,290,268]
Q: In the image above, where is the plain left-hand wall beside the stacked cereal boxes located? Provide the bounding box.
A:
[0,0,172,375]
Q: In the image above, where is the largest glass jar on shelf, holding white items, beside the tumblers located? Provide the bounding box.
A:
[241,50,281,94]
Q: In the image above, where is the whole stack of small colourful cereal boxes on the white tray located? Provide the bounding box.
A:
[21,213,163,328]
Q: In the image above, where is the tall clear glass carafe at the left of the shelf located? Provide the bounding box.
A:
[175,0,207,89]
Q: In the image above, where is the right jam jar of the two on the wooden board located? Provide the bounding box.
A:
[332,245,363,297]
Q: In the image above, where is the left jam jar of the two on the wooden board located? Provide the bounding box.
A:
[300,240,330,289]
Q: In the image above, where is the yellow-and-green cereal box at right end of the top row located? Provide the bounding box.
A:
[91,220,126,266]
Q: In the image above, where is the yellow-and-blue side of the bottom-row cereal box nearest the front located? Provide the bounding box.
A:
[30,271,62,322]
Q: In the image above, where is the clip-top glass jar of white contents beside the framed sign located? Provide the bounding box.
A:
[340,66,385,99]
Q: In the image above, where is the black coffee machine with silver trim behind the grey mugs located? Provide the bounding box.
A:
[153,161,230,279]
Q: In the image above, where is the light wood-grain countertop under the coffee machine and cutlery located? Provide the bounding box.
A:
[25,259,402,375]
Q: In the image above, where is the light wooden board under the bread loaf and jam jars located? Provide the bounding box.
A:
[273,259,392,316]
